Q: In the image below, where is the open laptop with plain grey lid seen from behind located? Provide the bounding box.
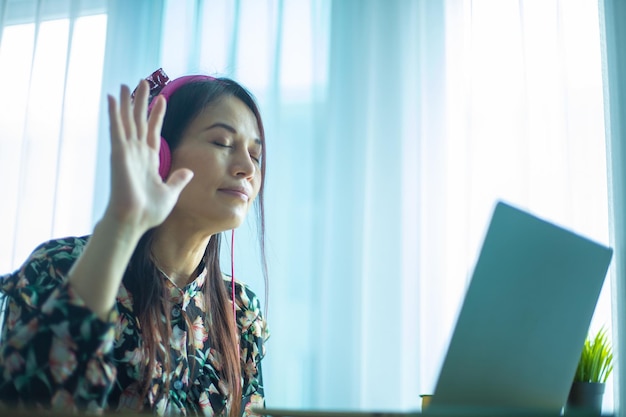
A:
[258,202,612,417]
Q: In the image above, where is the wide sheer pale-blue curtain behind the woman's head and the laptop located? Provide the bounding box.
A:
[154,0,612,410]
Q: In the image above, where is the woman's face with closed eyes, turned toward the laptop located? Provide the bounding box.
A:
[166,96,261,233]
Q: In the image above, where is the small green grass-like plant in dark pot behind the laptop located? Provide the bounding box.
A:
[565,327,613,414]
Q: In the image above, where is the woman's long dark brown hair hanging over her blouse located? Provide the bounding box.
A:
[123,78,268,417]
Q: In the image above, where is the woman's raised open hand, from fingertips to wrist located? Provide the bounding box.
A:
[105,80,193,233]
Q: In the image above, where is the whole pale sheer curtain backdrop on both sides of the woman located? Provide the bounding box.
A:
[0,0,615,410]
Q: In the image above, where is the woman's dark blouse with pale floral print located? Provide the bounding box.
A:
[0,237,269,416]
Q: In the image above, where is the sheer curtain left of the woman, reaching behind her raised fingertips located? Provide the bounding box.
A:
[0,0,163,272]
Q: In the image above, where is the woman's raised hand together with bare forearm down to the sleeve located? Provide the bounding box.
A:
[68,81,193,319]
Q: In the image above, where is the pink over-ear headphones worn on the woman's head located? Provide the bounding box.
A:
[140,68,215,181]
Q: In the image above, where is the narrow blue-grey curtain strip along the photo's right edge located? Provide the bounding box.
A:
[600,0,626,416]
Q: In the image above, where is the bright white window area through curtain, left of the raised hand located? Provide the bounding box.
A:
[0,0,107,273]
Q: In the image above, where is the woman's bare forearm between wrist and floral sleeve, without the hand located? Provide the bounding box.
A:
[68,216,143,319]
